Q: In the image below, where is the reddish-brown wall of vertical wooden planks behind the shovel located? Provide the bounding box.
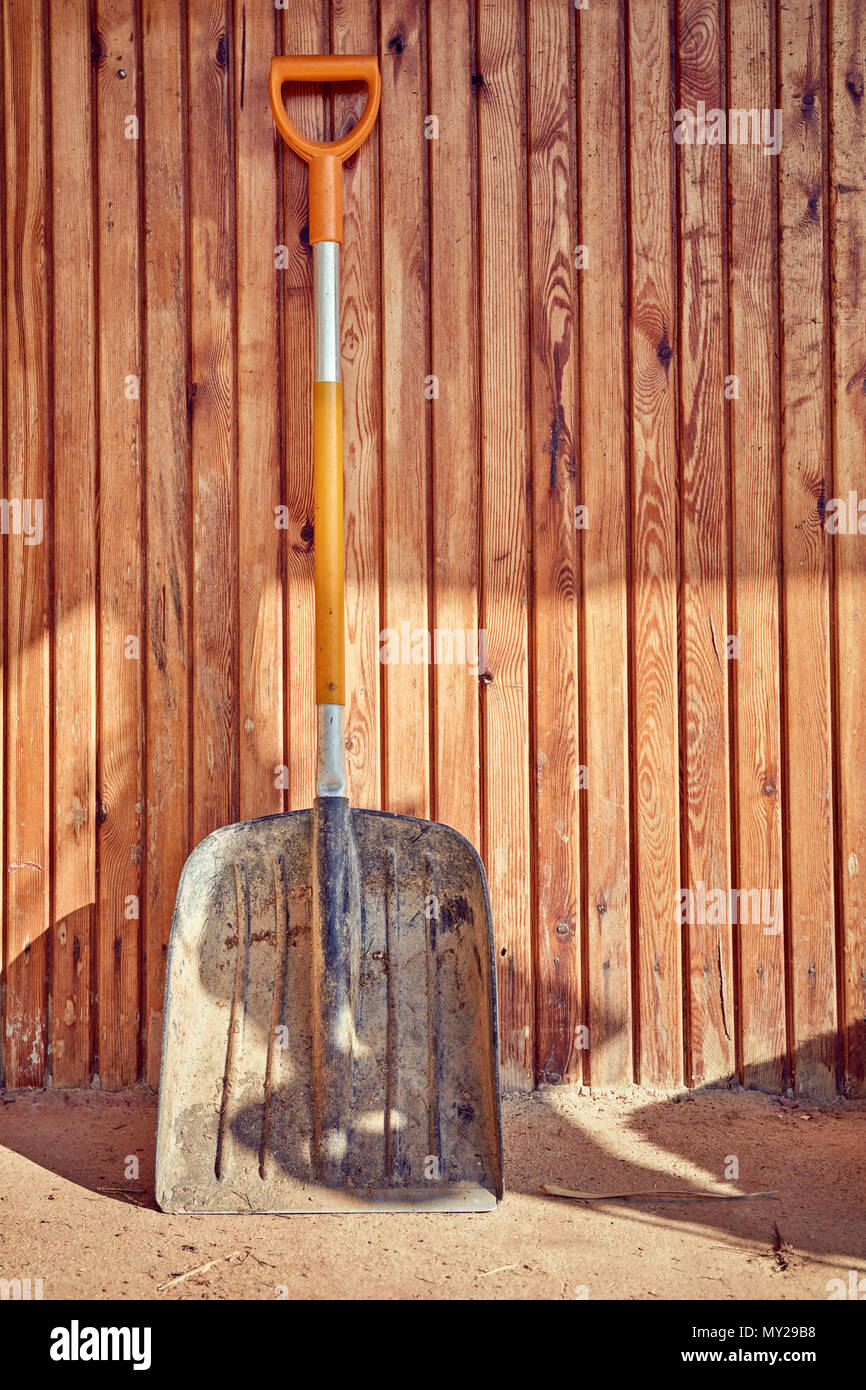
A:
[0,0,866,1095]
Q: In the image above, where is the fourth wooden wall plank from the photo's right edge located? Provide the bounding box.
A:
[677,0,737,1086]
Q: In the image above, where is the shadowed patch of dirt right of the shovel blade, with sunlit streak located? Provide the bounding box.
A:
[505,1023,866,1269]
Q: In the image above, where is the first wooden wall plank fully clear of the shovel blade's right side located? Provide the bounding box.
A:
[527,0,581,1083]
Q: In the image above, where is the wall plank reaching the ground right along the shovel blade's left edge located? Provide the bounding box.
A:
[142,0,192,1086]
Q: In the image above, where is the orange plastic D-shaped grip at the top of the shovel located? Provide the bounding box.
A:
[268,53,382,242]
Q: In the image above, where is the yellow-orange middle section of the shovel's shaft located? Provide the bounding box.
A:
[313,381,346,705]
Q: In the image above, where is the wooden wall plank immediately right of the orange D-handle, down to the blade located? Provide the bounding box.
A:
[379,0,430,816]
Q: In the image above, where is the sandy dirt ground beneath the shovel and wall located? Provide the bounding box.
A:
[0,1088,866,1300]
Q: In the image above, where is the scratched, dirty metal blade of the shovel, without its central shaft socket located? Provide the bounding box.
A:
[157,810,502,1212]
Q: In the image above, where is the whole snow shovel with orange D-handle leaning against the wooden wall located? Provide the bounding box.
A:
[156,56,502,1213]
